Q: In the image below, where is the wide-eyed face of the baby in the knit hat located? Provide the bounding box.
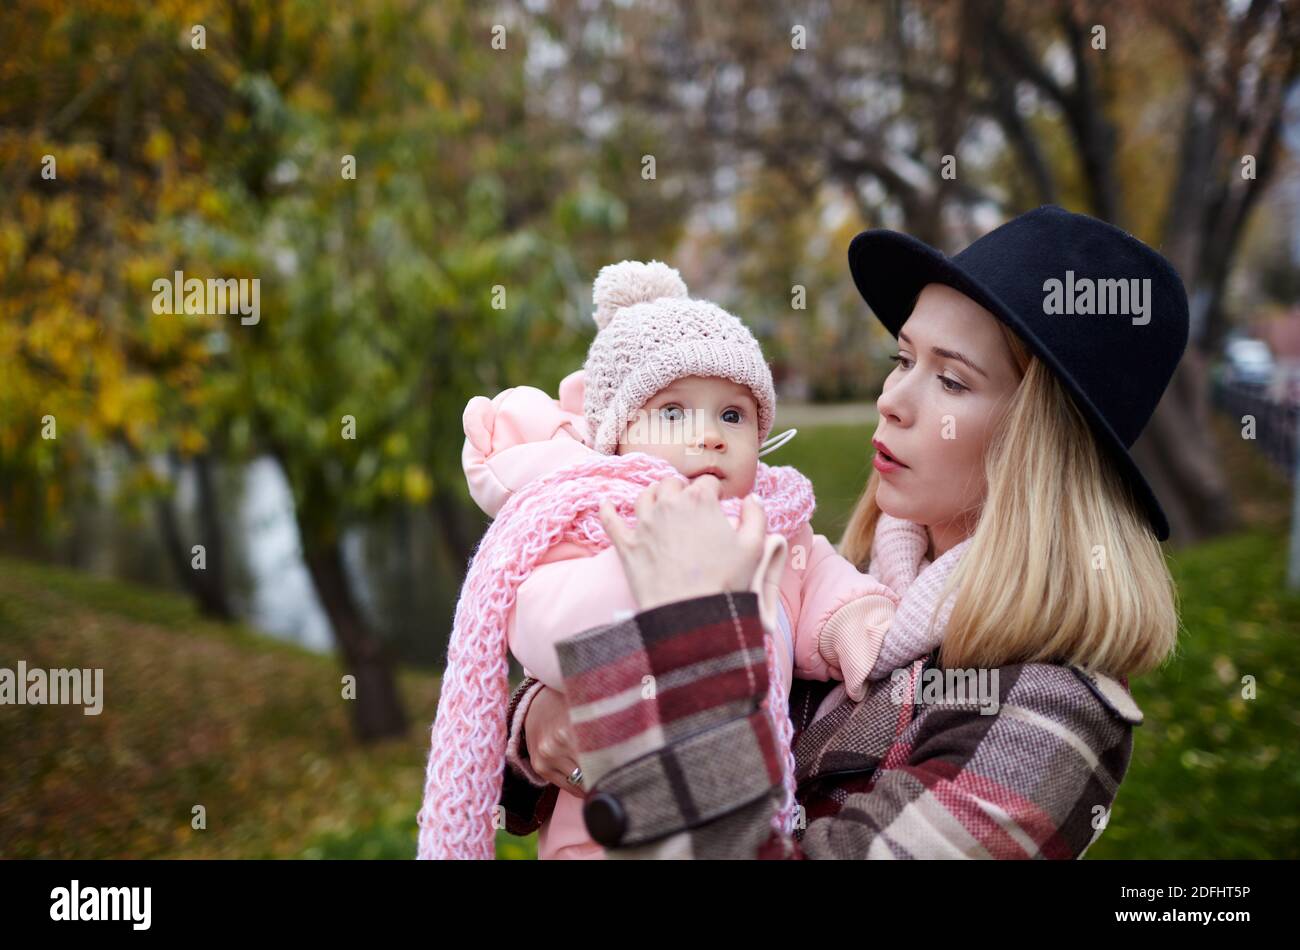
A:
[619,376,758,498]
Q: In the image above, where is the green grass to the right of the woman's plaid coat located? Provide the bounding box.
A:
[1088,530,1300,859]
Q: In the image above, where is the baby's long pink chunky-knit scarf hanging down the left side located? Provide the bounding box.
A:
[417,452,814,859]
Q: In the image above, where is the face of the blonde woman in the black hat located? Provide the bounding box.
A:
[872,283,1019,556]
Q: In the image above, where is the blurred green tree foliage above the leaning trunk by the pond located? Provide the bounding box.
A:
[153,4,595,546]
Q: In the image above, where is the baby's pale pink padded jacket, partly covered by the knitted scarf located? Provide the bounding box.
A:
[462,370,898,858]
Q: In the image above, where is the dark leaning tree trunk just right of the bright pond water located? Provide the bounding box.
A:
[303,539,407,742]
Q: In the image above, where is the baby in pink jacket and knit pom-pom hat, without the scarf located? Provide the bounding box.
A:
[452,261,898,859]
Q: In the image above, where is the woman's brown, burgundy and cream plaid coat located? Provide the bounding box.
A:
[502,593,1141,858]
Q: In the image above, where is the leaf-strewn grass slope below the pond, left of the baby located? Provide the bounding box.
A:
[0,559,536,859]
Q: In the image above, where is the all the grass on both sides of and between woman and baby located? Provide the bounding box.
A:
[0,421,1300,859]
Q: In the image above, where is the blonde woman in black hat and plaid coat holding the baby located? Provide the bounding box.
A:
[502,207,1188,858]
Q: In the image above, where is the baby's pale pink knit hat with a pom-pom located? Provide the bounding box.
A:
[582,261,776,455]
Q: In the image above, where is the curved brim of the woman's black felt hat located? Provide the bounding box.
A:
[849,229,1169,541]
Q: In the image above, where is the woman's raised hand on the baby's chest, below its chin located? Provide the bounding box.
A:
[601,476,767,611]
